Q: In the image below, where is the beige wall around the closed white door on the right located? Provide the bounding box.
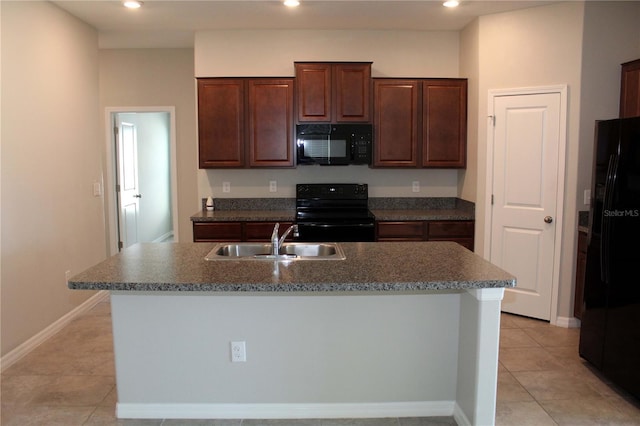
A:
[476,2,584,318]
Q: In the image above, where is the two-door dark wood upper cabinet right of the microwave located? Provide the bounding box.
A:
[373,78,467,168]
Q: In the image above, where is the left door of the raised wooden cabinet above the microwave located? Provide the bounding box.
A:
[295,63,332,122]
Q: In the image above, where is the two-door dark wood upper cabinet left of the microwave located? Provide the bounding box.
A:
[198,78,295,169]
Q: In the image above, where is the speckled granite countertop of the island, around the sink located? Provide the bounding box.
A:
[68,242,515,292]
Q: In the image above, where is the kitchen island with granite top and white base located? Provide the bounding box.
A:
[69,242,515,425]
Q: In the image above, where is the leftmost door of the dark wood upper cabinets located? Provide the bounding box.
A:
[198,79,245,169]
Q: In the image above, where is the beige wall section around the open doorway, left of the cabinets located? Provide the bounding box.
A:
[100,49,196,241]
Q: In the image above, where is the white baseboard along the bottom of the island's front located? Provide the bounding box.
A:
[116,401,456,419]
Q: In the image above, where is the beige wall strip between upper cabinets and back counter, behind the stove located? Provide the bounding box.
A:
[198,165,458,198]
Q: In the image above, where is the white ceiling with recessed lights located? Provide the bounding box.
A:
[53,0,556,48]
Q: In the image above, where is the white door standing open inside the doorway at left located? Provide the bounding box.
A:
[116,121,142,248]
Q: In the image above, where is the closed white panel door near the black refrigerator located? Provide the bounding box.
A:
[490,92,564,320]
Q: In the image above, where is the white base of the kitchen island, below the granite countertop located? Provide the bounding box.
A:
[111,288,504,425]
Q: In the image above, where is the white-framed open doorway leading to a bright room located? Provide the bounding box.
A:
[105,107,178,254]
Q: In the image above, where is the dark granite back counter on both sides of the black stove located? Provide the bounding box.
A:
[191,197,475,222]
